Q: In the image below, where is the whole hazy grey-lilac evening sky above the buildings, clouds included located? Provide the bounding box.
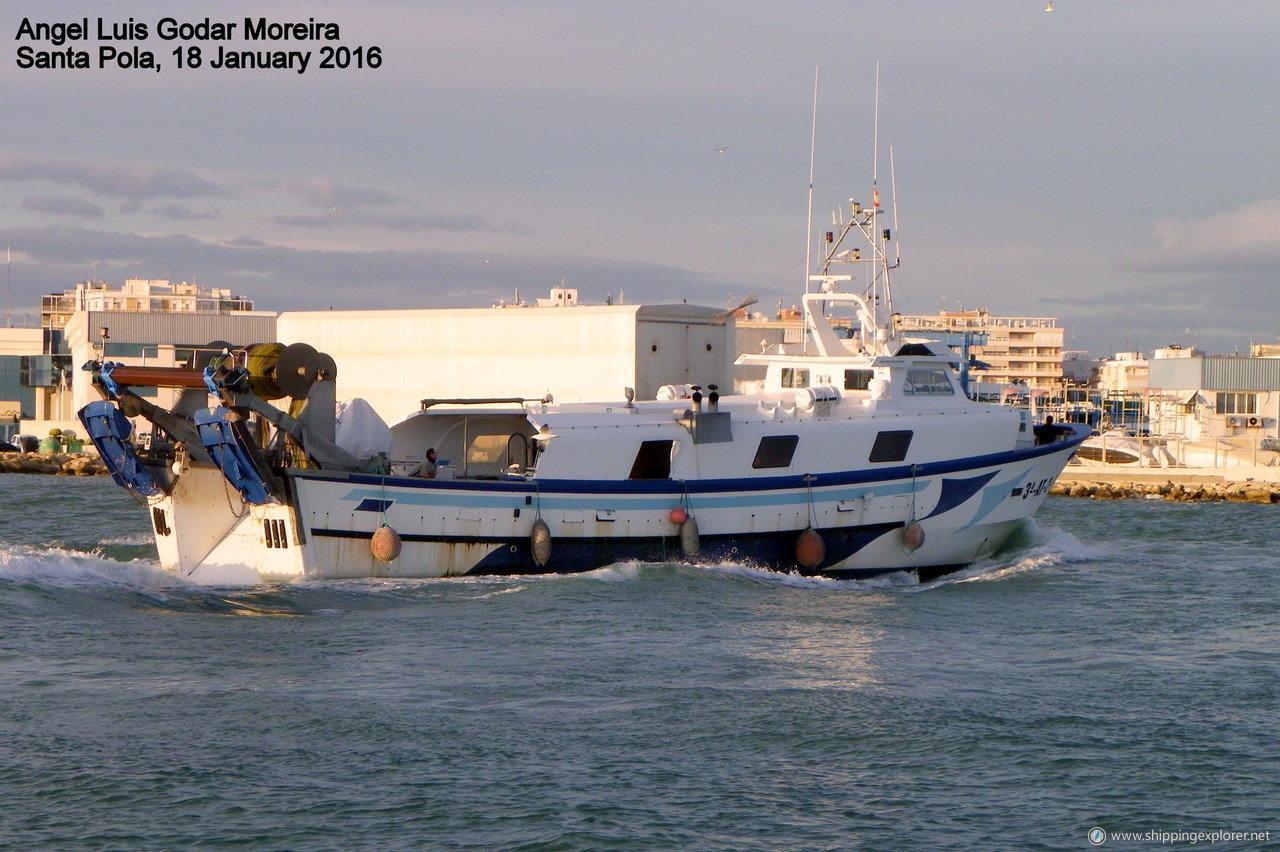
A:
[0,0,1280,357]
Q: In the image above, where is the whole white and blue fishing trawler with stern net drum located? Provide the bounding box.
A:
[81,190,1088,583]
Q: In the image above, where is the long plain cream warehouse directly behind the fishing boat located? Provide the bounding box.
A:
[278,288,737,423]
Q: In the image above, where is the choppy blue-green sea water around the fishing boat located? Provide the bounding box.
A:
[0,475,1280,849]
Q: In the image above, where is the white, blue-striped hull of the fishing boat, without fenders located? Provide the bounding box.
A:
[152,440,1076,583]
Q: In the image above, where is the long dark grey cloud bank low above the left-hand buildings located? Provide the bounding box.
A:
[0,225,741,311]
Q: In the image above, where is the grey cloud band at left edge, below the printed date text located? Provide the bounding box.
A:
[0,154,224,198]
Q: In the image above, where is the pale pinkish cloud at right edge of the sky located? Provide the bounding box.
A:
[1112,198,1280,274]
